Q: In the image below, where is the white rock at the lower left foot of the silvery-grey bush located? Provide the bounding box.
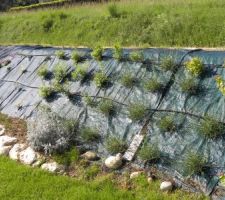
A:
[19,147,37,165]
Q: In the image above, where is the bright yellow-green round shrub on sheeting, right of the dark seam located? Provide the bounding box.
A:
[185,57,204,76]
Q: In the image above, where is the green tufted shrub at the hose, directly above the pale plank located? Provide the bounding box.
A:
[128,104,147,121]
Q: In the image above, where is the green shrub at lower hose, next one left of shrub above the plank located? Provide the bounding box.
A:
[98,99,116,117]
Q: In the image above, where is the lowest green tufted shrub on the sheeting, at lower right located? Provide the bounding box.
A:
[184,152,207,176]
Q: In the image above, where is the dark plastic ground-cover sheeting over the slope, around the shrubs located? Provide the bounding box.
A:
[0,46,225,197]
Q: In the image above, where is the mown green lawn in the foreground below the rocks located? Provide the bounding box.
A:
[0,157,206,200]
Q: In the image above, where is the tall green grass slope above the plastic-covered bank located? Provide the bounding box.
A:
[0,0,225,47]
